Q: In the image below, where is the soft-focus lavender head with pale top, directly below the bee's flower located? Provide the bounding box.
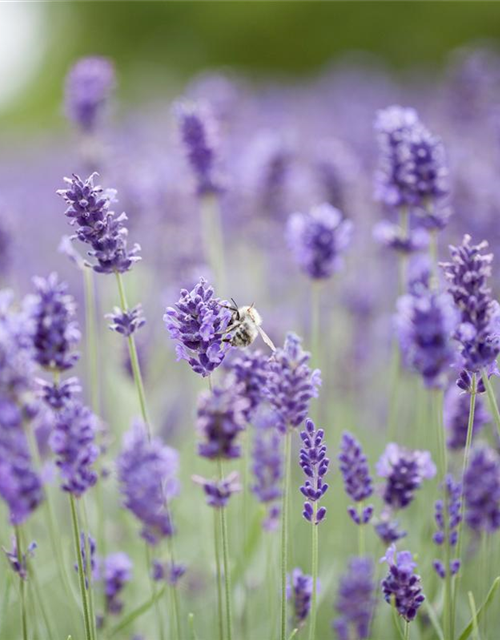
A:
[197,379,250,460]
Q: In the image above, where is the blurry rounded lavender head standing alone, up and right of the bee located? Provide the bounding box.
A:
[286,202,352,279]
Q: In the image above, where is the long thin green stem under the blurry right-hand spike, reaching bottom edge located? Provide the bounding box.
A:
[434,391,455,640]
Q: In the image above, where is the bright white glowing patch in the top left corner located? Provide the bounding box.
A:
[0,2,46,111]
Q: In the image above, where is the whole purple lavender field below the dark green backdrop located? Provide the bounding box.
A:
[0,38,500,640]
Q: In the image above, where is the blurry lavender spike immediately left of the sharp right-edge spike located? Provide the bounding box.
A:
[396,291,458,388]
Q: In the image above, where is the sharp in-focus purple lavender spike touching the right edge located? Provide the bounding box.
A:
[441,235,500,372]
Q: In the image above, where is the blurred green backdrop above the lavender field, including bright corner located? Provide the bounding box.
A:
[0,0,500,127]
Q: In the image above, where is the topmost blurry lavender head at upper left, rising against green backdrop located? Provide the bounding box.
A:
[65,56,115,133]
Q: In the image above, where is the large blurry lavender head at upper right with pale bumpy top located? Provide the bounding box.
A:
[375,106,449,207]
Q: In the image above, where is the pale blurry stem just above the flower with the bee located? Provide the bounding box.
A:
[200,195,226,292]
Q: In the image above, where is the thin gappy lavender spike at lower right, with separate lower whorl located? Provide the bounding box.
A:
[433,475,462,579]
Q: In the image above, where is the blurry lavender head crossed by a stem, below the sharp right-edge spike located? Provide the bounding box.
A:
[443,384,490,451]
